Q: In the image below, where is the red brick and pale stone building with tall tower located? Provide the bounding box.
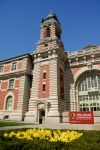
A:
[0,12,100,124]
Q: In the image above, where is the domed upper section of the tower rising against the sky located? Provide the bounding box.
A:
[37,9,62,51]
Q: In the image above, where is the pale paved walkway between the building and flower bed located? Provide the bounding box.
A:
[0,123,100,130]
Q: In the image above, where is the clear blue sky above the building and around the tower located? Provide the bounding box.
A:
[0,0,100,60]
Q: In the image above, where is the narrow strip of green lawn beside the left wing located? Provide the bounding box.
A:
[0,120,32,127]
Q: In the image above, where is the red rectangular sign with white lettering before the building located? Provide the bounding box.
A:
[69,111,94,124]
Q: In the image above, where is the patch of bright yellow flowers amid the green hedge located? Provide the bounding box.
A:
[4,129,82,143]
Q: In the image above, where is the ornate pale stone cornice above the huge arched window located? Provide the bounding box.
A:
[67,46,100,67]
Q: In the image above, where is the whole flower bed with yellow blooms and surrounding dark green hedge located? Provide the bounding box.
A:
[0,129,100,150]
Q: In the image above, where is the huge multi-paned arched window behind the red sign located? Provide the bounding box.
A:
[78,73,100,111]
